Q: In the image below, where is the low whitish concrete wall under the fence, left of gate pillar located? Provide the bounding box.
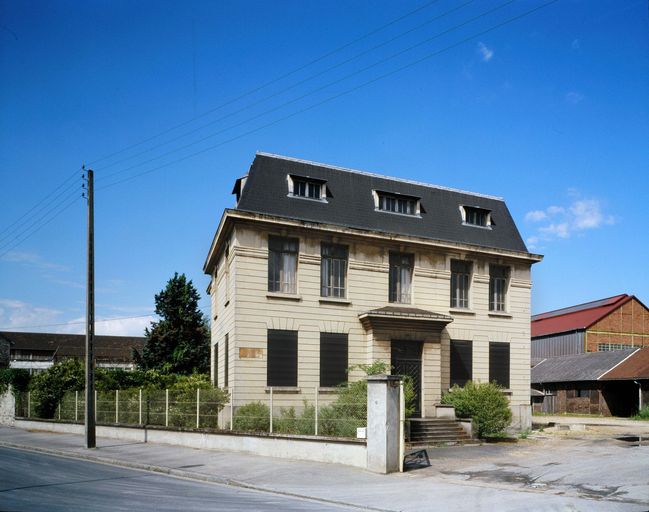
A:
[15,419,367,469]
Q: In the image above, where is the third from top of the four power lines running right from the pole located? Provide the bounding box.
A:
[96,0,516,184]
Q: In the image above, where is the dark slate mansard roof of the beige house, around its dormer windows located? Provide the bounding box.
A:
[235,153,528,253]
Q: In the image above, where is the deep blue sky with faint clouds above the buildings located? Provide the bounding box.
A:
[0,0,649,334]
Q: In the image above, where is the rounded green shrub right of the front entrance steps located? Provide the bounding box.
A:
[442,381,512,437]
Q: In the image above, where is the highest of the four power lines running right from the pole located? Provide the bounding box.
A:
[90,0,439,165]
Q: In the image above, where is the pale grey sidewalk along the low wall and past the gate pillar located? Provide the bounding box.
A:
[0,427,647,512]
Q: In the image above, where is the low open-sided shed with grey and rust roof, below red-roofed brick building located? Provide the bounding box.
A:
[531,348,649,416]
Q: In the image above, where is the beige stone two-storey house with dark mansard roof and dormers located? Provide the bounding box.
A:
[204,153,541,427]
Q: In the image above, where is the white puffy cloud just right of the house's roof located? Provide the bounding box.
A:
[525,190,615,249]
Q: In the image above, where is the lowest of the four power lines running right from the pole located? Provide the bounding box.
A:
[98,0,558,190]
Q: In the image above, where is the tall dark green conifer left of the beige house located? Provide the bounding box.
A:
[133,272,210,375]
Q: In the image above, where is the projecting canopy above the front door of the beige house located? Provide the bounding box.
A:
[358,306,453,334]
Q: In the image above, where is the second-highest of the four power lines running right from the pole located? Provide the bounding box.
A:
[95,0,476,176]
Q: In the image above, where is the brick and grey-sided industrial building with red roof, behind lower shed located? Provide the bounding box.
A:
[531,294,649,359]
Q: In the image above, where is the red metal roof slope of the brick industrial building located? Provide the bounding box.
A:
[532,293,633,338]
